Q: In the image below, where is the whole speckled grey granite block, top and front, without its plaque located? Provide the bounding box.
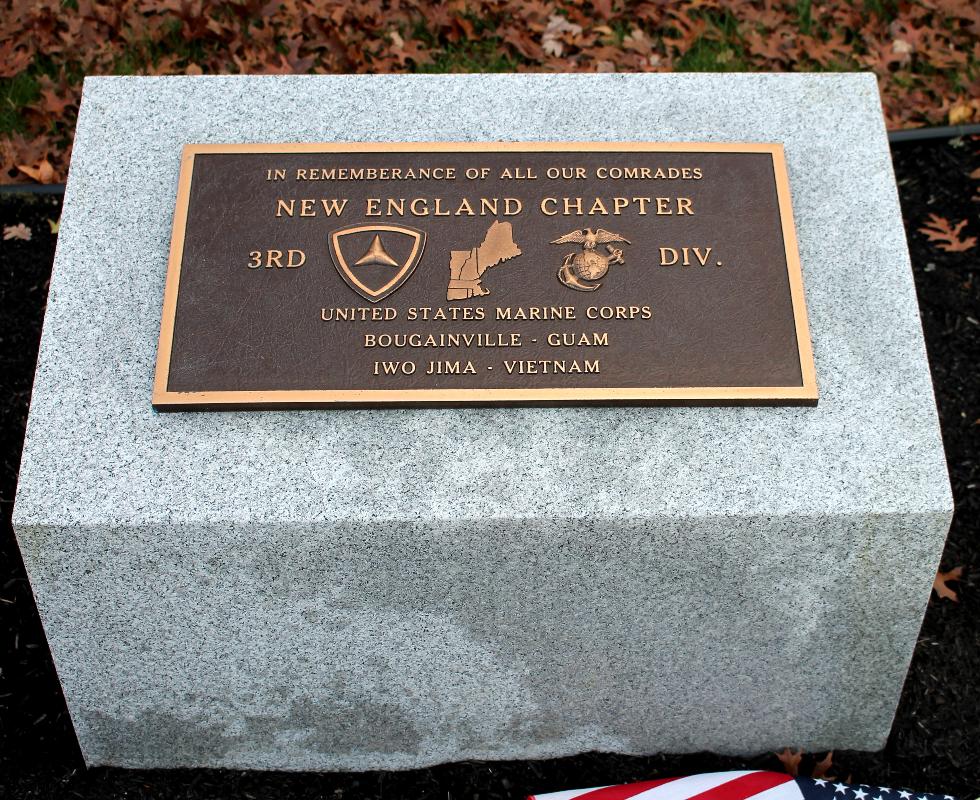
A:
[14,75,952,769]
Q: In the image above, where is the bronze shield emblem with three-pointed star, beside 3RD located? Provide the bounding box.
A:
[330,225,425,303]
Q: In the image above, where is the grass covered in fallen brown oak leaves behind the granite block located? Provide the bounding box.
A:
[0,0,980,183]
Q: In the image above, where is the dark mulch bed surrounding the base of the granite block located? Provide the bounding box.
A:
[0,140,980,800]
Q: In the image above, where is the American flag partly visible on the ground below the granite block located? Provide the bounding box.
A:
[528,770,954,800]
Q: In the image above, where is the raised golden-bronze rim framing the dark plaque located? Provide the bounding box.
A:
[152,141,819,411]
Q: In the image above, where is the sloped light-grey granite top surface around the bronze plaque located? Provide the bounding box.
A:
[15,74,952,528]
